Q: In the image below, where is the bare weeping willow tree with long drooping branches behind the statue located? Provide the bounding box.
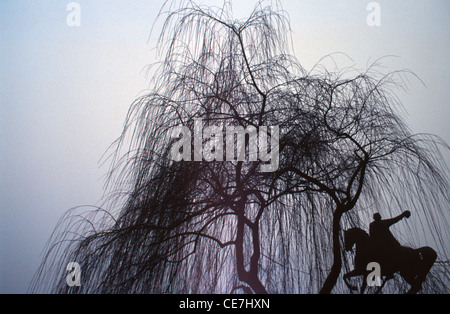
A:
[31,1,450,293]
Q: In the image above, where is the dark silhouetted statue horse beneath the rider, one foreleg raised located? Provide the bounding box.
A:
[344,228,437,294]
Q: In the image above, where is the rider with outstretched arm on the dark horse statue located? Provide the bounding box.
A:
[369,211,411,278]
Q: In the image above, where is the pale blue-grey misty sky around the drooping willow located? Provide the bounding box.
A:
[0,0,450,293]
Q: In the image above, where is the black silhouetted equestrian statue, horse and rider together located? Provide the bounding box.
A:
[344,211,437,294]
